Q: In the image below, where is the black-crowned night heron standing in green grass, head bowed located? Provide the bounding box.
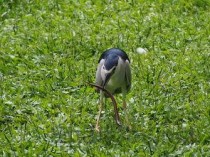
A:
[95,48,131,131]
